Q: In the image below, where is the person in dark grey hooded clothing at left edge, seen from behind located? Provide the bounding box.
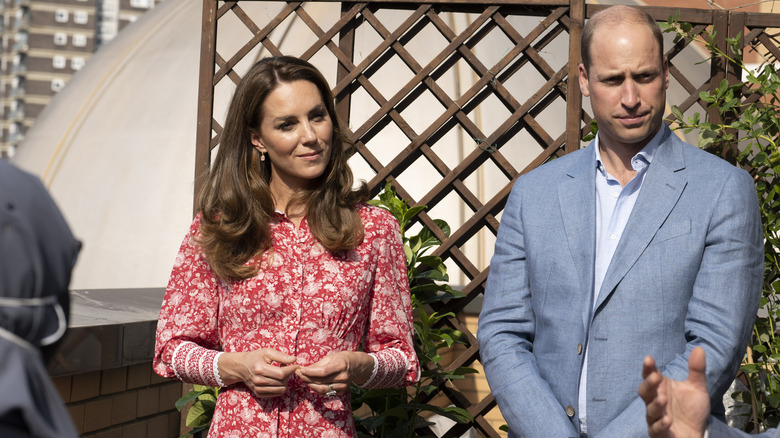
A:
[0,160,81,438]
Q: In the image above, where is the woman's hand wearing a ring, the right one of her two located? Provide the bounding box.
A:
[296,351,374,395]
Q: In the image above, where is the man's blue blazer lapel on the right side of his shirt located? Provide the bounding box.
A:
[595,127,687,309]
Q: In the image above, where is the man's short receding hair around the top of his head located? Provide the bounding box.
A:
[580,5,664,71]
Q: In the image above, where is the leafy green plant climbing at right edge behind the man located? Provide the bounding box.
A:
[664,11,780,430]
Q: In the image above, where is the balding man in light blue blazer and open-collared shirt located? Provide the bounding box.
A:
[478,6,763,438]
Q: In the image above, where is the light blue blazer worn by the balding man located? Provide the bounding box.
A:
[477,125,764,438]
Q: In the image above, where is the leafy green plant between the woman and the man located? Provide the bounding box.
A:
[351,182,477,438]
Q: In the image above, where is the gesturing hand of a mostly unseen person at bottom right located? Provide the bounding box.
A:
[639,347,780,438]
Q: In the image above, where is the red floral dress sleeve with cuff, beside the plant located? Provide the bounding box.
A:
[361,209,420,388]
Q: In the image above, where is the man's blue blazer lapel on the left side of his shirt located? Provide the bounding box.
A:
[558,143,596,327]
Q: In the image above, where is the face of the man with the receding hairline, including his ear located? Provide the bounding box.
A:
[579,23,669,151]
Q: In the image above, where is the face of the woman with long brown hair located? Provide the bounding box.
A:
[251,80,333,191]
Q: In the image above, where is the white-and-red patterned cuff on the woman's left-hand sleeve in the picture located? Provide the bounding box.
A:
[171,342,225,387]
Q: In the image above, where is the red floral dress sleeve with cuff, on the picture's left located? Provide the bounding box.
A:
[152,216,224,386]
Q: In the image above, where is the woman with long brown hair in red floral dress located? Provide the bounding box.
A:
[154,57,420,438]
